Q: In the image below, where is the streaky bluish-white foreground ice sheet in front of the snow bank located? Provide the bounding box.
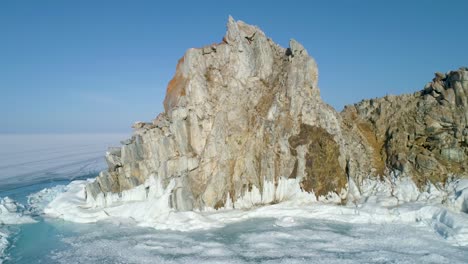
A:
[48,218,468,264]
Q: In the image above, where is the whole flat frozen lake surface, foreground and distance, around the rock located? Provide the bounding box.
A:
[0,135,468,264]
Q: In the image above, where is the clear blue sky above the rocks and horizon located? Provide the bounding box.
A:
[0,0,468,133]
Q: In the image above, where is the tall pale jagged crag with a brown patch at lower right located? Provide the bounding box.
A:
[86,18,346,210]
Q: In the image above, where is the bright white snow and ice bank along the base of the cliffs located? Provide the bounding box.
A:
[44,178,468,246]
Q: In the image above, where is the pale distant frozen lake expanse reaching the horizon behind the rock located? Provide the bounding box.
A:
[0,134,128,190]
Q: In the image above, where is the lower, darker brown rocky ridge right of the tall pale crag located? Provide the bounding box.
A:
[341,68,468,187]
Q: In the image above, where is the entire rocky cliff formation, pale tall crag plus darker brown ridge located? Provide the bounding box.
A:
[86,18,468,210]
